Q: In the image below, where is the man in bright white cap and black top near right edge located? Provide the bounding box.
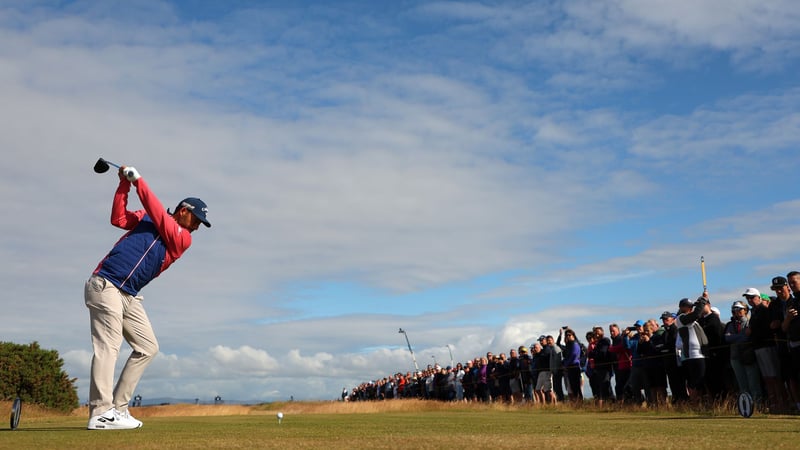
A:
[742,288,788,413]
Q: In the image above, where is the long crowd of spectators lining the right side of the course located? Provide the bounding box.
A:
[342,272,800,413]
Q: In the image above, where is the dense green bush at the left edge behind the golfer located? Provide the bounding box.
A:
[0,342,79,412]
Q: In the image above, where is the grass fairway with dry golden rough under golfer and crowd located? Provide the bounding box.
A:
[0,400,800,449]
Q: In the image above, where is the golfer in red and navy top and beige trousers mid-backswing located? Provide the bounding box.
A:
[84,166,211,430]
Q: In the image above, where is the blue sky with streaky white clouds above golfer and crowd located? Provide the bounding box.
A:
[0,0,800,403]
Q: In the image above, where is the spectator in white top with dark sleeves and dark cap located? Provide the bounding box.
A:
[675,297,708,403]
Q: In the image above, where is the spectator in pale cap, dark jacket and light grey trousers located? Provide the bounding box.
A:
[725,295,763,404]
